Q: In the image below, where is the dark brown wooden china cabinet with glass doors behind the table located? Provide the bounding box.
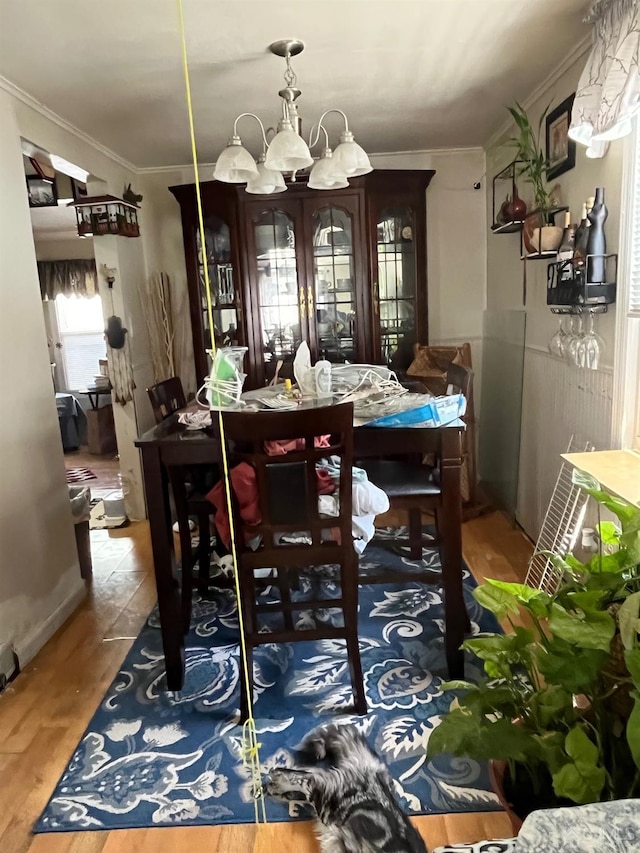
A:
[170,169,435,387]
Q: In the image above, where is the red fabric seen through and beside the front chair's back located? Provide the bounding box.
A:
[207,435,335,548]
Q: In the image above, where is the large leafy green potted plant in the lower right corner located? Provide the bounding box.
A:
[428,472,640,833]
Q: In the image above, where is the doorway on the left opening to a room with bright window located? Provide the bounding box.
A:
[23,147,122,527]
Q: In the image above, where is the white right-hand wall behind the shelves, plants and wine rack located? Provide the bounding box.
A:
[487,50,625,539]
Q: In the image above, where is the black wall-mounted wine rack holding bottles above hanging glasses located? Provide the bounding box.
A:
[547,254,618,314]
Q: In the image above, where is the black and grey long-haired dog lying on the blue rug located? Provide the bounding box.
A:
[265,725,428,853]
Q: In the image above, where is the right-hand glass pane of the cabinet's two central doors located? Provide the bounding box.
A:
[309,207,356,362]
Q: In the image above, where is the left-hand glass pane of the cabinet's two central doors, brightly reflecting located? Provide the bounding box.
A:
[253,210,307,381]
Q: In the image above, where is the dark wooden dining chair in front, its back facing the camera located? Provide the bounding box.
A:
[223,404,367,719]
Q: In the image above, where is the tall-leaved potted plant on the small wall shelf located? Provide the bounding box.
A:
[507,102,562,254]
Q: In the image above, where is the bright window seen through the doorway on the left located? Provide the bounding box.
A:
[56,296,107,391]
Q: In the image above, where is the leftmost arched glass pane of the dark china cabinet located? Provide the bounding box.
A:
[196,216,244,363]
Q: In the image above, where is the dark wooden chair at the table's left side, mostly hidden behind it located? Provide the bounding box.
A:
[147,376,217,632]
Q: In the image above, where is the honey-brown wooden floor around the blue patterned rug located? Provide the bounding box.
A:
[0,513,531,853]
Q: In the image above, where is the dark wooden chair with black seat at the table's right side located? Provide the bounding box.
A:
[357,364,473,568]
